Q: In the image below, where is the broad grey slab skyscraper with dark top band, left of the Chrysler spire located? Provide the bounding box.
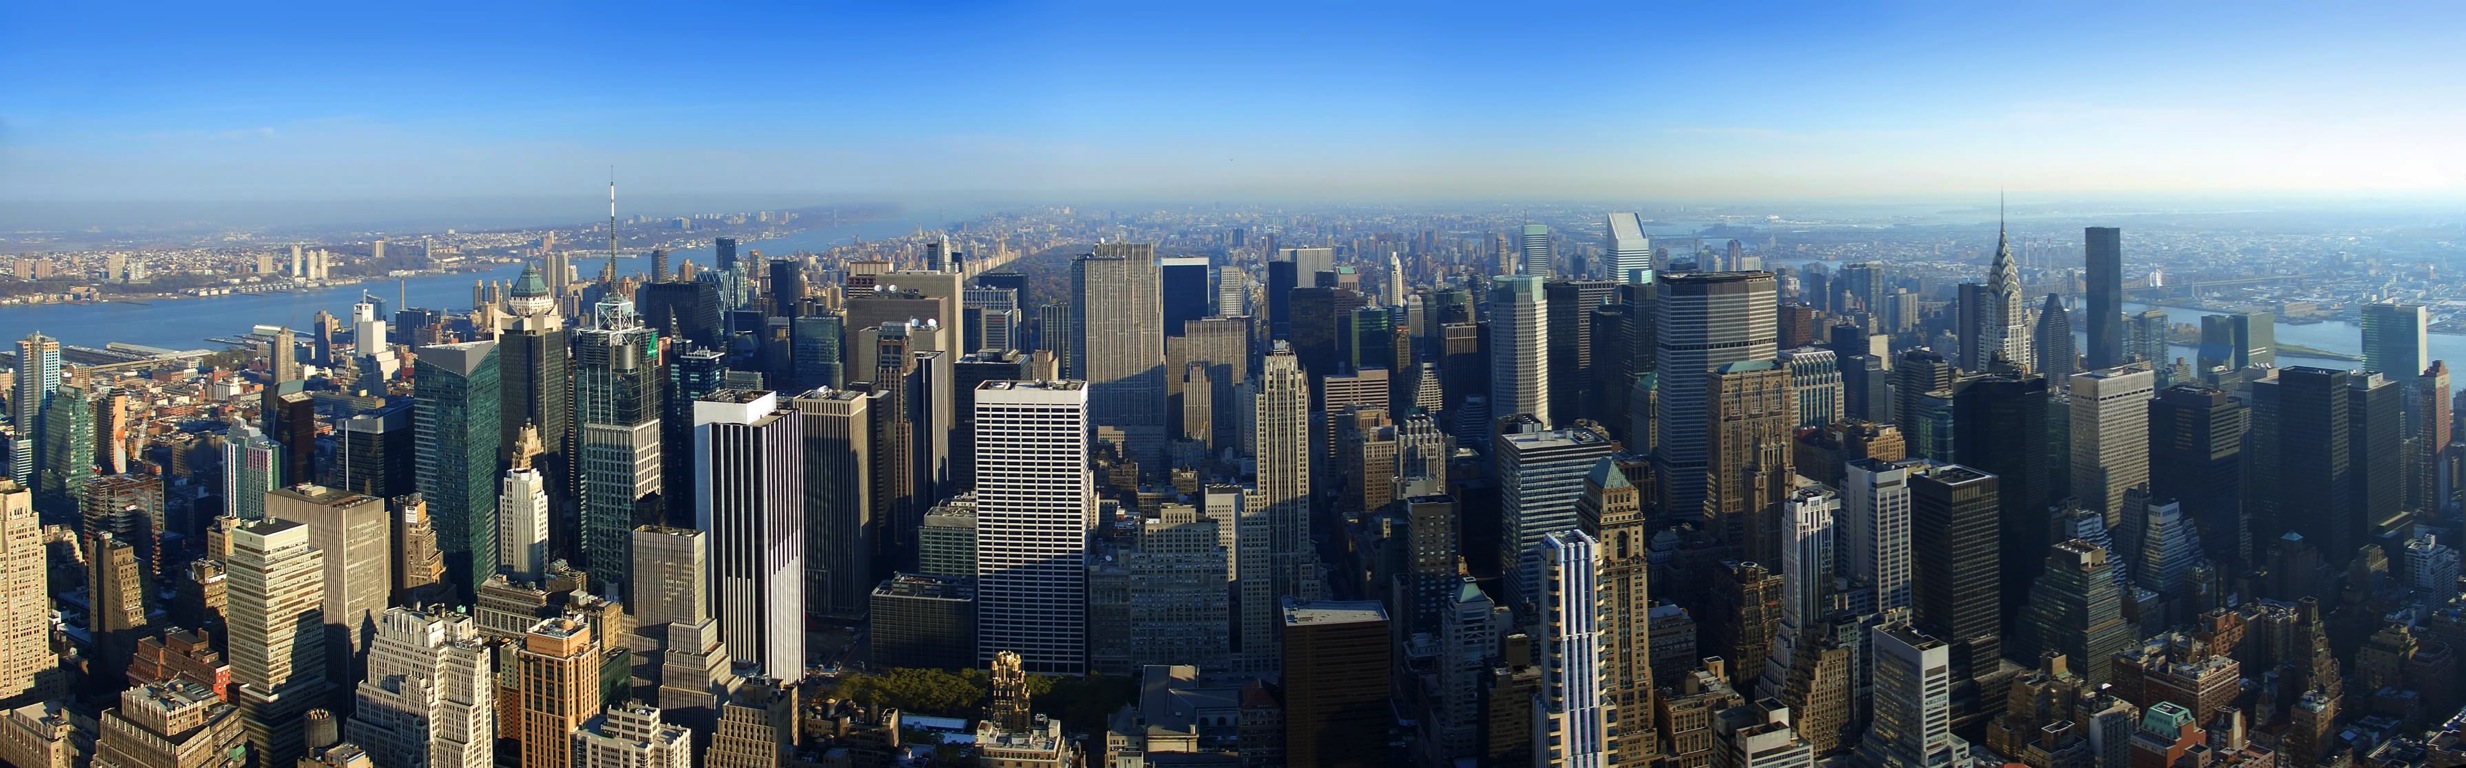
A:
[1652,272,1778,523]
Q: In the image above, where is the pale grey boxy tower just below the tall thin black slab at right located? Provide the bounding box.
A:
[2069,365,2158,528]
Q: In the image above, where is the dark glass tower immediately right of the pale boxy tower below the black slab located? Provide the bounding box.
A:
[2150,385,2254,563]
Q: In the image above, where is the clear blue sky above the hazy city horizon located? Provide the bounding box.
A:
[0,2,2466,208]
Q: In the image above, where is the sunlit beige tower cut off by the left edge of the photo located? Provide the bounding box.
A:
[0,482,69,706]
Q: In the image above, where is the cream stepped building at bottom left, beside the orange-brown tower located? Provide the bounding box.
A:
[345,607,496,768]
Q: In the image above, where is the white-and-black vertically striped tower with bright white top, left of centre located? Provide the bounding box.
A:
[693,390,804,677]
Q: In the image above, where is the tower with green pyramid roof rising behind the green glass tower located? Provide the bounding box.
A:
[496,267,575,506]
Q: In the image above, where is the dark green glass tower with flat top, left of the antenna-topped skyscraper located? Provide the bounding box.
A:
[412,341,503,600]
